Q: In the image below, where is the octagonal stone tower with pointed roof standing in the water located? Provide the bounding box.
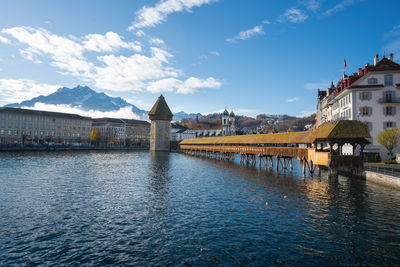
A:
[149,95,172,151]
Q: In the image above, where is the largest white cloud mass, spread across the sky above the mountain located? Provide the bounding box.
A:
[2,27,220,94]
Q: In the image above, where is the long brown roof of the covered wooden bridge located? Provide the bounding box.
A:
[180,120,371,145]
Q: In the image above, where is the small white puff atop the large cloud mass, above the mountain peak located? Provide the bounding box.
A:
[83,32,142,52]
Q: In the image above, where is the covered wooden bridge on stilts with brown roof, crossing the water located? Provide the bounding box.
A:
[179,120,370,174]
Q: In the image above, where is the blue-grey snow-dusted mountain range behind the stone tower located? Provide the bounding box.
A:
[6,85,201,121]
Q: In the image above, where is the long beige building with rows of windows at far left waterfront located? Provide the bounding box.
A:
[0,107,92,144]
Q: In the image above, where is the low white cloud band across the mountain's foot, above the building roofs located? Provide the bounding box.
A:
[22,102,143,120]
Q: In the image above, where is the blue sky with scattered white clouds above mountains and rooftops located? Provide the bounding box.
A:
[0,0,400,116]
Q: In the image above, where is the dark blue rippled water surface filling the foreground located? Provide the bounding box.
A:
[0,152,400,266]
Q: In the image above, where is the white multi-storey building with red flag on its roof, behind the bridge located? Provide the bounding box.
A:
[317,54,400,159]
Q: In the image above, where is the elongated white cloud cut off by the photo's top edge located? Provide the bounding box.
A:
[128,0,218,30]
